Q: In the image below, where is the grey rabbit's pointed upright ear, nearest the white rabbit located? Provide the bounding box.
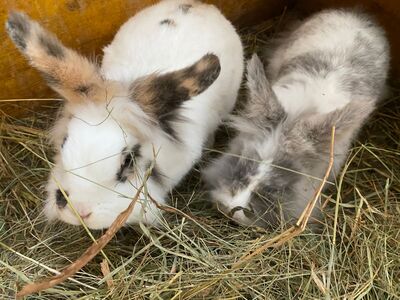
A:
[244,54,286,127]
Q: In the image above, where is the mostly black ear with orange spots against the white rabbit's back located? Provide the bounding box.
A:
[130,54,221,133]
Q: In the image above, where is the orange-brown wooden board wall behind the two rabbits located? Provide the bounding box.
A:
[0,0,400,116]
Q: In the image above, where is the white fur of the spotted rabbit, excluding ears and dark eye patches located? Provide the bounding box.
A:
[45,0,243,229]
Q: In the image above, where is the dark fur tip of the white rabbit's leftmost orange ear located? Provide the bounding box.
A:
[6,12,30,51]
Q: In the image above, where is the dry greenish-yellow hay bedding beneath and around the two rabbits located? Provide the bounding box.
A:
[0,14,400,299]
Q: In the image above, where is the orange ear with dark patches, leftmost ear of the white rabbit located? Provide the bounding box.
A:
[6,12,104,102]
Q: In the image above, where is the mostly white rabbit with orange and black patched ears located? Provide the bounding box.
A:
[6,0,244,229]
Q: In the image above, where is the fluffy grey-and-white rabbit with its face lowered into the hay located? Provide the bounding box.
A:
[203,10,389,230]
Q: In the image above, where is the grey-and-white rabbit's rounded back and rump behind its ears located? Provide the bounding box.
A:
[268,10,389,115]
